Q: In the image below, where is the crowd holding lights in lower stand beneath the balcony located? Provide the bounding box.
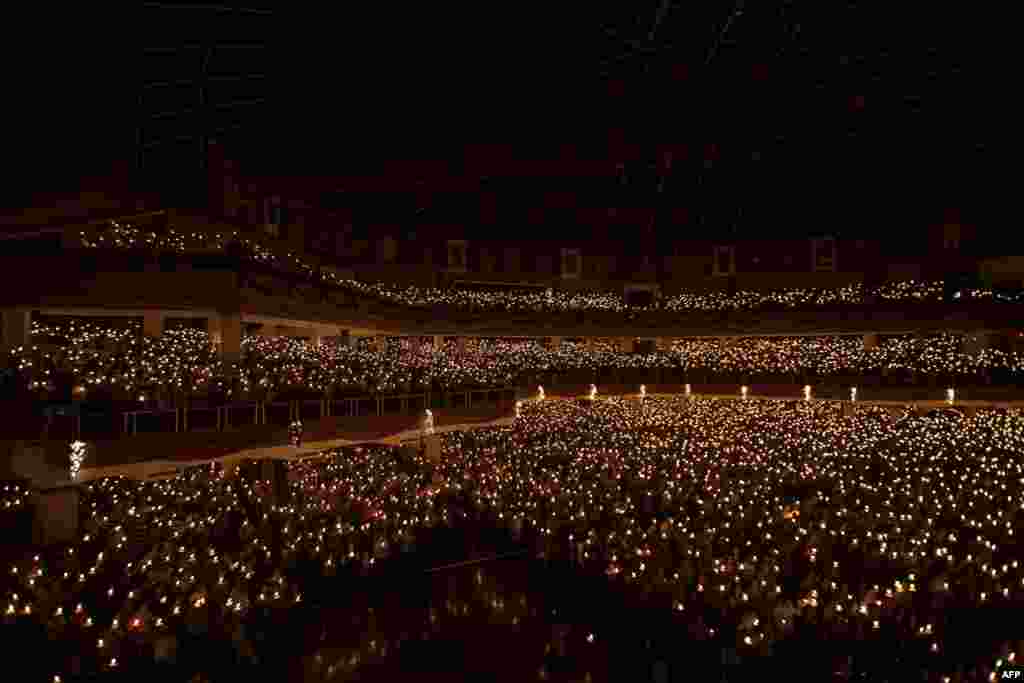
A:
[5,318,1024,409]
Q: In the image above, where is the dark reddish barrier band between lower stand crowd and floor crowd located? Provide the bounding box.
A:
[4,367,1024,448]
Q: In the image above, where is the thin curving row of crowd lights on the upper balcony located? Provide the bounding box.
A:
[75,222,1024,313]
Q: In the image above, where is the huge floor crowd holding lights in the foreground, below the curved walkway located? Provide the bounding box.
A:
[0,397,1024,681]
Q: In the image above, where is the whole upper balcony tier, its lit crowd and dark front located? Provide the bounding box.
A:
[0,218,1024,337]
